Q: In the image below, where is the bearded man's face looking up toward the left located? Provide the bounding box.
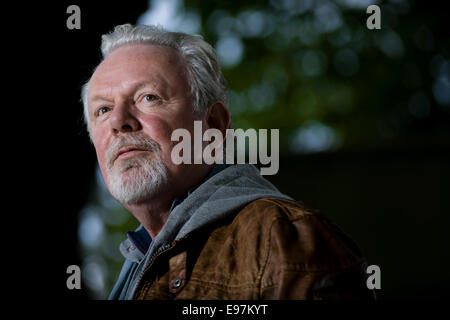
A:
[88,44,206,204]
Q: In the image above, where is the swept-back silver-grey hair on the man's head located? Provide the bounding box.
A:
[81,24,228,140]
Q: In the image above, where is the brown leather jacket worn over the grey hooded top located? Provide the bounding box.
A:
[134,198,374,300]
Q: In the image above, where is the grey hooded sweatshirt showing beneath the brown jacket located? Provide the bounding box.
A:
[109,164,292,300]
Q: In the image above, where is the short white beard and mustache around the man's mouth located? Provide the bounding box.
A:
[107,137,168,204]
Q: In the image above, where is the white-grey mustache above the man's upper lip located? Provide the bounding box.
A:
[106,134,161,168]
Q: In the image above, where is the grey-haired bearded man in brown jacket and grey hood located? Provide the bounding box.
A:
[82,25,371,299]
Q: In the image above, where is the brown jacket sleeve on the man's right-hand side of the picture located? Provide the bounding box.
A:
[260,213,374,300]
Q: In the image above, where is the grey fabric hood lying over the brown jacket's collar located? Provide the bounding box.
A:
[149,164,292,255]
